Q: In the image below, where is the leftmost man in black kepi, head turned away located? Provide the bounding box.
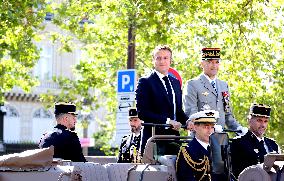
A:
[39,103,86,162]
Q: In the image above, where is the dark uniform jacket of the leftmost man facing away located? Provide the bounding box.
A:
[39,124,86,162]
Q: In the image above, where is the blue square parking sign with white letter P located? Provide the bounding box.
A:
[117,69,136,93]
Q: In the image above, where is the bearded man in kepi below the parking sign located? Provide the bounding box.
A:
[118,107,142,163]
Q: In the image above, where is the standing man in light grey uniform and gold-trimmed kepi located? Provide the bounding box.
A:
[183,48,247,134]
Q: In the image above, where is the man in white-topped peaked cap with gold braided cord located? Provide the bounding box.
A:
[176,110,219,181]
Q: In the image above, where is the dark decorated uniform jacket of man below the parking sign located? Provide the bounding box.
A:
[117,131,142,163]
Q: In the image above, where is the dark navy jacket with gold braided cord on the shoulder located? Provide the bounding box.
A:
[176,138,211,181]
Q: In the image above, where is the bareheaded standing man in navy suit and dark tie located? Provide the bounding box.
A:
[136,46,188,153]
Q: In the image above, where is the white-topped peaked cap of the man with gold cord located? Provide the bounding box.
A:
[189,110,219,123]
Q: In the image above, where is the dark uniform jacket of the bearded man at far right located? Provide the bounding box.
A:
[231,131,280,177]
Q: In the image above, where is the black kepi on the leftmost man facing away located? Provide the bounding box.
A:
[54,102,78,115]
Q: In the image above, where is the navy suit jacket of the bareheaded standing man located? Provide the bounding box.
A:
[136,71,188,153]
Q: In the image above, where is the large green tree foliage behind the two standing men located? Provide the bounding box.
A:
[42,0,284,152]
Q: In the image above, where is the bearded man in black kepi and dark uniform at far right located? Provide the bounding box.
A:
[231,104,280,178]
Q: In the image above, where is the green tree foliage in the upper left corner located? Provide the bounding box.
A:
[0,0,45,103]
